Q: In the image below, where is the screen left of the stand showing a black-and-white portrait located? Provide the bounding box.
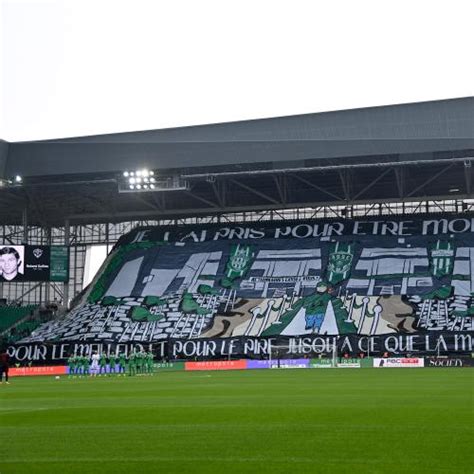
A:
[0,245,69,282]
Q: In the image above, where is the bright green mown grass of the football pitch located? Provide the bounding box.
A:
[0,368,474,474]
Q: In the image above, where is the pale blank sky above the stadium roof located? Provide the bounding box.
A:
[0,0,474,141]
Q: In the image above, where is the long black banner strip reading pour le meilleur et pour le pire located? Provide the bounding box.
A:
[8,332,473,364]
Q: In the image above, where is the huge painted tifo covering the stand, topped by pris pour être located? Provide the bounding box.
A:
[23,215,474,343]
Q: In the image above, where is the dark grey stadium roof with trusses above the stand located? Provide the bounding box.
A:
[0,97,474,226]
